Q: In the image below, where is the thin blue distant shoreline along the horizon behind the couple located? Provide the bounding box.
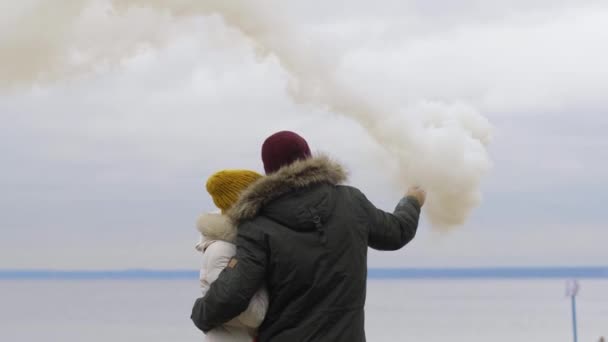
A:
[0,267,608,281]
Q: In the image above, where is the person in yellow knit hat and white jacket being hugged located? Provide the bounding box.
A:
[196,170,268,342]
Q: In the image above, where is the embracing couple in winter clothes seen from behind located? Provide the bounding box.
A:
[191,131,425,342]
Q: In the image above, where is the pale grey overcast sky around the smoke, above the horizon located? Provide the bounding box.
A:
[0,0,608,269]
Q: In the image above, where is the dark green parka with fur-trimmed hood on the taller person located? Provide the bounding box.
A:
[192,156,420,342]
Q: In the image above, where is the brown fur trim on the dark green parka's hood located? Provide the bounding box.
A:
[227,155,347,225]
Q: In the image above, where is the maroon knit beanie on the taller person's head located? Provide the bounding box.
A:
[262,131,311,174]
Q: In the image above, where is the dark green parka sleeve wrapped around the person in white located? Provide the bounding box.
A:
[191,224,267,332]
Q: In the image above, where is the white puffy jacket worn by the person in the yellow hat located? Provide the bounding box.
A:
[196,213,268,342]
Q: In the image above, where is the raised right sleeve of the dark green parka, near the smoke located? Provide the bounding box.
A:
[357,190,420,251]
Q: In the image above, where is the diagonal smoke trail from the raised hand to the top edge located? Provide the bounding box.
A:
[115,0,491,227]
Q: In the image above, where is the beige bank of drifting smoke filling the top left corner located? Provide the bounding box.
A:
[0,0,176,89]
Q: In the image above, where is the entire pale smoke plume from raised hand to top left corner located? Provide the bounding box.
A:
[0,0,491,227]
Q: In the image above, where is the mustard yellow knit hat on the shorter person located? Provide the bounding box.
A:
[207,170,262,214]
